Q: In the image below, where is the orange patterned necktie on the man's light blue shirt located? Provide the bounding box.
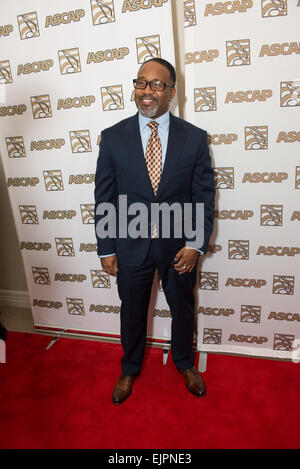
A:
[146,121,162,195]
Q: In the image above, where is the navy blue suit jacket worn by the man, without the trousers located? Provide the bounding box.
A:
[95,113,215,266]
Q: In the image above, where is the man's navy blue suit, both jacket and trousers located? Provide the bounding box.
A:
[95,113,215,375]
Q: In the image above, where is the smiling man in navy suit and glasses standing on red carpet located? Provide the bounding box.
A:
[95,58,215,404]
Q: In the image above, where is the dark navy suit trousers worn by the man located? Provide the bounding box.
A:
[117,239,197,376]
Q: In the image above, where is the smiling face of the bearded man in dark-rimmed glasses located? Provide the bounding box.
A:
[134,62,176,119]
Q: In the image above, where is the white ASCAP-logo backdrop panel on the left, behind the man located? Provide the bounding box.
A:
[0,0,176,339]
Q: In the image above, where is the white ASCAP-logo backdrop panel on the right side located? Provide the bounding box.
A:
[184,0,300,358]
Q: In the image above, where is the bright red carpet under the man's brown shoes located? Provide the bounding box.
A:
[0,332,300,449]
